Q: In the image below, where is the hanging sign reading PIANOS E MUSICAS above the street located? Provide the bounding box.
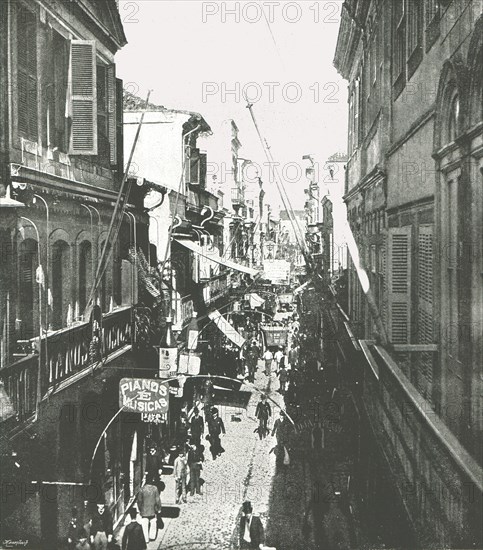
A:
[119,378,169,414]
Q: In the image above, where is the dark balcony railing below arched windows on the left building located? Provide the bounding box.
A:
[0,307,132,421]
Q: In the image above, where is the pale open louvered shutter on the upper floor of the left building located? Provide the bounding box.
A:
[69,40,97,155]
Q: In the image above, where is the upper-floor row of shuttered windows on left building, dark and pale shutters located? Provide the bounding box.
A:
[15,9,118,160]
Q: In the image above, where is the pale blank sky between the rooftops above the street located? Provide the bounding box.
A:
[117,0,347,210]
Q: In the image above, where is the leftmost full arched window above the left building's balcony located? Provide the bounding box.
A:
[18,239,39,340]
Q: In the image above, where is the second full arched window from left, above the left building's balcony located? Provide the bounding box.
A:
[51,241,72,330]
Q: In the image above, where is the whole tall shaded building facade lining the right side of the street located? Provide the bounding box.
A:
[334,0,483,546]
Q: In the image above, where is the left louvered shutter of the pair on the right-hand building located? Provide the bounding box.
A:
[387,227,411,344]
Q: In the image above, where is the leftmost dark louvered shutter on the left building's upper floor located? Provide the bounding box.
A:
[17,5,38,141]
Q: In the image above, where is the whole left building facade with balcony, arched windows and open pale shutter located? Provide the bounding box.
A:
[0,0,153,548]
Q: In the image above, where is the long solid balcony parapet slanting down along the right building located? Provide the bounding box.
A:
[331,304,483,548]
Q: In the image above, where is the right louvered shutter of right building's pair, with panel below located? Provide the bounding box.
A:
[417,226,434,401]
